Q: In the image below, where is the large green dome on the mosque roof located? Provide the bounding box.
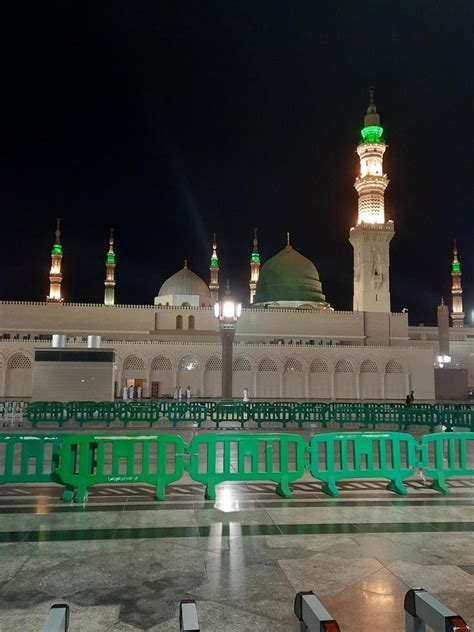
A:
[254,244,326,303]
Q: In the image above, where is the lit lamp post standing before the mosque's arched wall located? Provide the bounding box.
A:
[214,282,242,399]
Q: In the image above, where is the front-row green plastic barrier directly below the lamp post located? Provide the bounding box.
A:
[188,433,306,500]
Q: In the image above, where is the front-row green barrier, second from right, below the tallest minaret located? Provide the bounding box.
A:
[309,432,418,496]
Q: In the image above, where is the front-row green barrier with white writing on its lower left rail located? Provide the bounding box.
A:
[55,434,184,503]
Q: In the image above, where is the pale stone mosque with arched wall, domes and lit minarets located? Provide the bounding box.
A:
[0,93,474,401]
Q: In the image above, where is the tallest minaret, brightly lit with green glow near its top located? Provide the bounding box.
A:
[349,88,395,313]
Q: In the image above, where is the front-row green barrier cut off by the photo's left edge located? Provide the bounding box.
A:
[0,433,63,485]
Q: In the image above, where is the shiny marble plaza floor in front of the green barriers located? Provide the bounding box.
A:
[0,422,474,632]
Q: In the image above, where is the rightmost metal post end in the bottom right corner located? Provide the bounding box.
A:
[404,588,470,632]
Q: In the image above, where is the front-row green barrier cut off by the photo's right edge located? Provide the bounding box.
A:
[421,432,474,494]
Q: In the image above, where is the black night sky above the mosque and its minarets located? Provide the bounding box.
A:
[0,0,474,324]
